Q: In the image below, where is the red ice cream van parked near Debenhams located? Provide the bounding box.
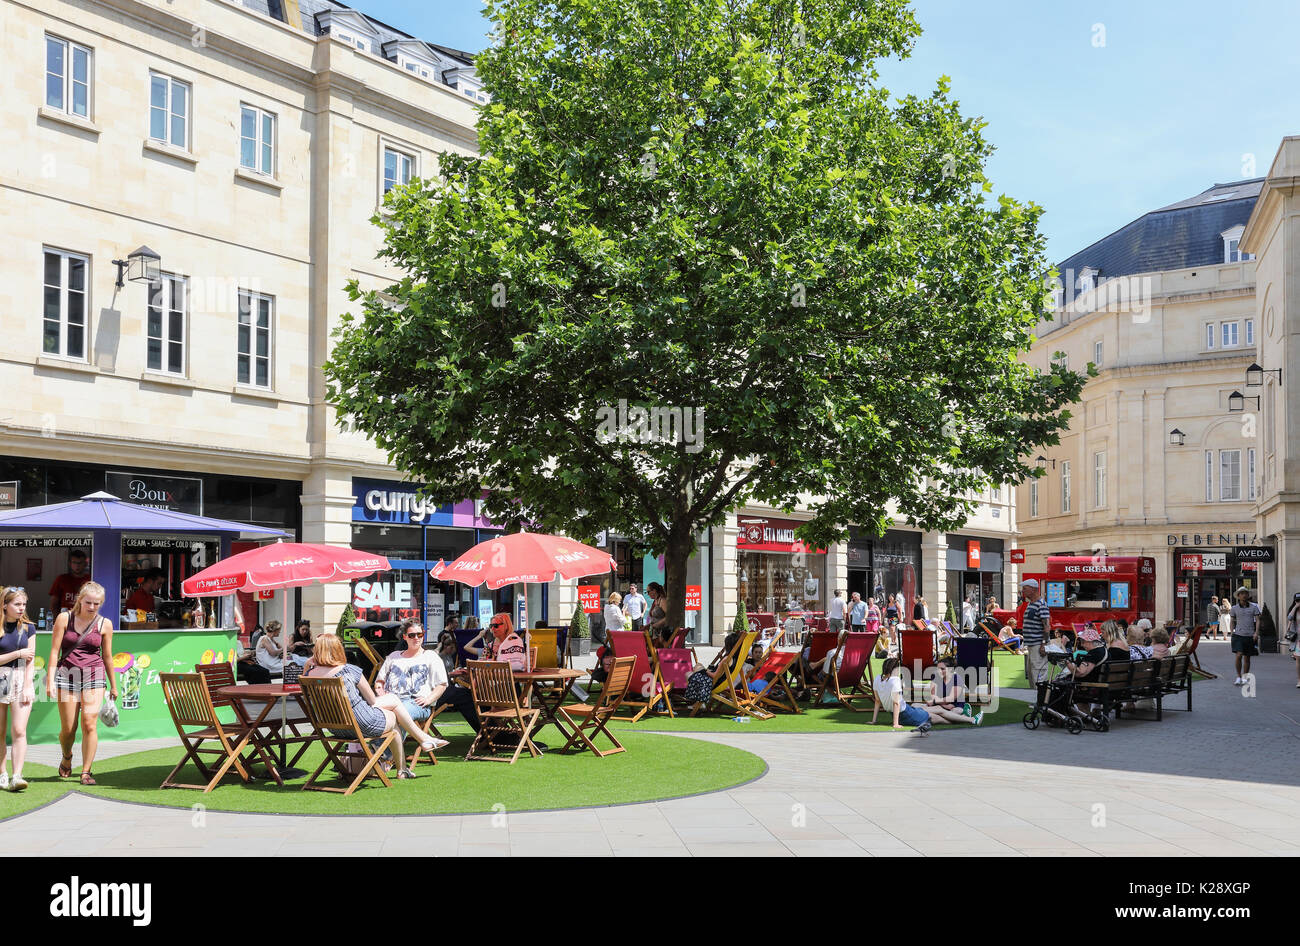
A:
[995,555,1156,628]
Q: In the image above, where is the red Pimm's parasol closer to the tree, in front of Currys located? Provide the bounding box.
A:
[429,531,619,670]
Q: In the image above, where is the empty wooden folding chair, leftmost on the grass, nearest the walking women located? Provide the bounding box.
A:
[159,673,278,794]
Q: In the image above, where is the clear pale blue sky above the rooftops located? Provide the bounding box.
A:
[352,0,1300,262]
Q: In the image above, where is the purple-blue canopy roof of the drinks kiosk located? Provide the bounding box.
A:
[0,492,289,538]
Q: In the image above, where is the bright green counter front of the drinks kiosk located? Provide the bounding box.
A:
[27,628,239,745]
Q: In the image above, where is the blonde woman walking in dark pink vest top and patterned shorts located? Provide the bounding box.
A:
[46,581,117,785]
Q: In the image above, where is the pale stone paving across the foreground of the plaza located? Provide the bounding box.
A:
[4,642,1300,856]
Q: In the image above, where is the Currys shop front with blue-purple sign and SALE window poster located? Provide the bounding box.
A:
[352,477,533,641]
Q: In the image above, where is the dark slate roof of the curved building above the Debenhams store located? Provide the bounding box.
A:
[1057,178,1264,282]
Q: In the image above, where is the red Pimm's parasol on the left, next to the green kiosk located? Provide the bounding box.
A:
[181,542,390,778]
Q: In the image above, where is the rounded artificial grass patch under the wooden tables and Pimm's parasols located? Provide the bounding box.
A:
[69,725,767,815]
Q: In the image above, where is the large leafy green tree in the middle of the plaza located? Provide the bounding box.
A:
[325,0,1083,631]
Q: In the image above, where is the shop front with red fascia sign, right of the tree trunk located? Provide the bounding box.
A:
[736,516,828,613]
